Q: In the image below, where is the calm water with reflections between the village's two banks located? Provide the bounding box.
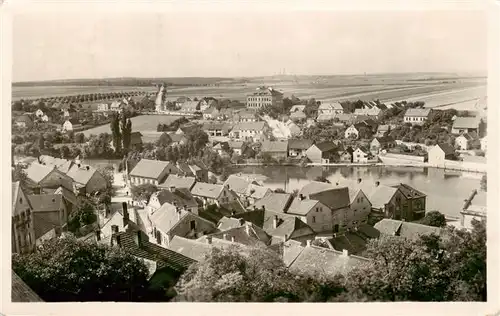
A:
[85,160,482,217]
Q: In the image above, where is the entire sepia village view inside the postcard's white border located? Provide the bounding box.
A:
[0,0,498,315]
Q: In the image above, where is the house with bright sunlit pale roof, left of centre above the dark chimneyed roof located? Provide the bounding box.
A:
[149,203,217,247]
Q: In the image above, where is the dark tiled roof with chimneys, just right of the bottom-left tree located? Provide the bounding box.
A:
[116,231,196,272]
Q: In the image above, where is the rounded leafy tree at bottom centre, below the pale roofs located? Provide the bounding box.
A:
[176,246,302,302]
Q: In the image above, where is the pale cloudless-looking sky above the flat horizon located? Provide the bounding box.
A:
[12,10,487,82]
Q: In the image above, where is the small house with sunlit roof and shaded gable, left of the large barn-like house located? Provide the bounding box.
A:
[286,195,334,233]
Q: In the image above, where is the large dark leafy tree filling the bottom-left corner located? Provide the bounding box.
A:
[12,237,148,302]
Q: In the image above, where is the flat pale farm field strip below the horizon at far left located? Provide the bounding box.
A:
[12,86,155,101]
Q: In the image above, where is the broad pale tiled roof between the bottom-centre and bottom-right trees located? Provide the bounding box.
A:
[290,246,369,277]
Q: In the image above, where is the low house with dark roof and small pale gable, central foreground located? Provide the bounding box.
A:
[233,209,316,244]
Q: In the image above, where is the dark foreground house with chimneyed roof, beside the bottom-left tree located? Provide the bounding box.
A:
[111,230,196,295]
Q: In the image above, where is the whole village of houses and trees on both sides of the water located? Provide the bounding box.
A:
[12,85,487,302]
